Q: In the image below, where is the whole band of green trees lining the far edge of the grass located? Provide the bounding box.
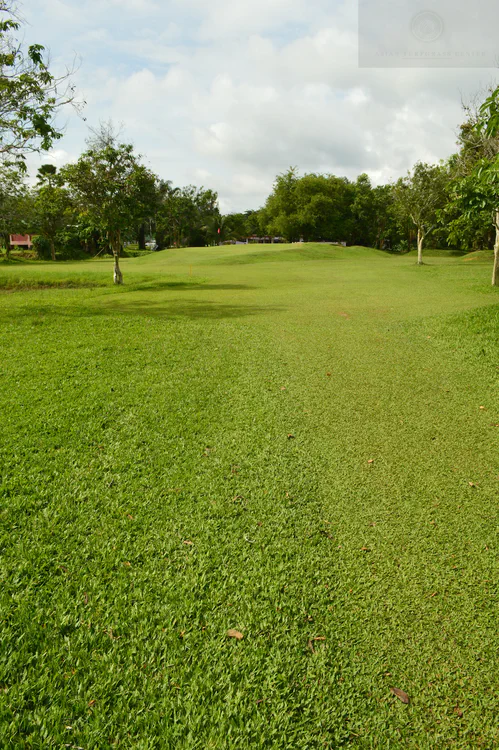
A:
[0,0,499,285]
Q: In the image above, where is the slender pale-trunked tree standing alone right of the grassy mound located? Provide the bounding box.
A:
[395,162,449,266]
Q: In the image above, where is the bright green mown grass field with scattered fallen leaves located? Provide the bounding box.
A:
[0,245,499,750]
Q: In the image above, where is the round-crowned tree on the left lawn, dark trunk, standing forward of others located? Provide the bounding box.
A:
[61,133,156,284]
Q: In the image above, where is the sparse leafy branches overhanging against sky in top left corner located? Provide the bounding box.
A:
[0,0,79,165]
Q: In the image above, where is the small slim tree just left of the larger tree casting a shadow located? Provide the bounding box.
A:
[33,164,71,261]
